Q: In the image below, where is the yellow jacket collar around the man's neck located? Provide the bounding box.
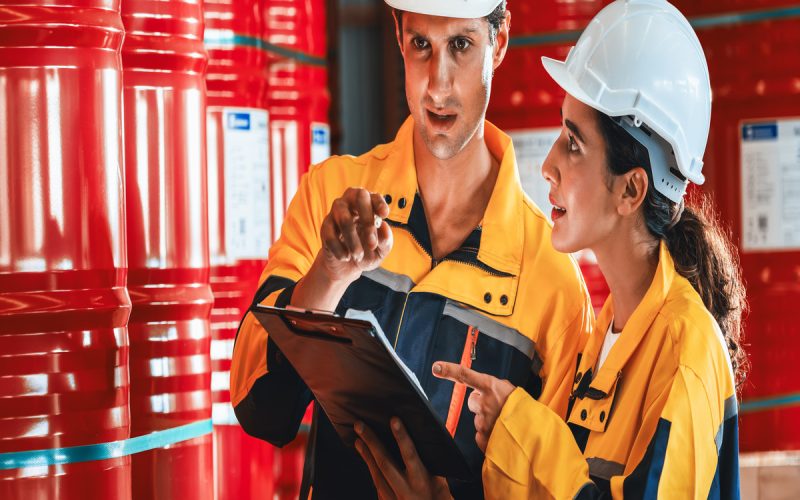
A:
[375,116,525,276]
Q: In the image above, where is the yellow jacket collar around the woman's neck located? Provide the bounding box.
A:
[576,241,677,394]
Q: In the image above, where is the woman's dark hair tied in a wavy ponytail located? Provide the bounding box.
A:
[598,113,748,387]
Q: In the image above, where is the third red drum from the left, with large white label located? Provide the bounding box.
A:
[204,0,274,499]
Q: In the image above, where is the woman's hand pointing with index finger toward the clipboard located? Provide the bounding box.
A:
[433,361,515,453]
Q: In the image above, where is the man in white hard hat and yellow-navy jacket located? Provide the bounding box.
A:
[231,0,592,498]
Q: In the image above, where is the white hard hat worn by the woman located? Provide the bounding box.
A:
[542,0,711,203]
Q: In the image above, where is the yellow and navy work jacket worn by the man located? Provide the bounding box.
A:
[231,118,592,498]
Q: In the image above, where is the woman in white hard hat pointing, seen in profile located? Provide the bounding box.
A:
[433,0,745,498]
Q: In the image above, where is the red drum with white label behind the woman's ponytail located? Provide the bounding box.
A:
[677,0,800,452]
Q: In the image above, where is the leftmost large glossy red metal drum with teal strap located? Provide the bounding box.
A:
[0,0,131,499]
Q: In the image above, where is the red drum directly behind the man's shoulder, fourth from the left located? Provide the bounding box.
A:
[261,0,330,239]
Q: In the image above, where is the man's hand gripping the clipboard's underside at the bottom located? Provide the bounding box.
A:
[355,418,452,500]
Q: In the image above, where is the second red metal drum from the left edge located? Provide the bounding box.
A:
[122,0,214,499]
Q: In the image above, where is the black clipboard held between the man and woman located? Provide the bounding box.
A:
[250,305,475,479]
